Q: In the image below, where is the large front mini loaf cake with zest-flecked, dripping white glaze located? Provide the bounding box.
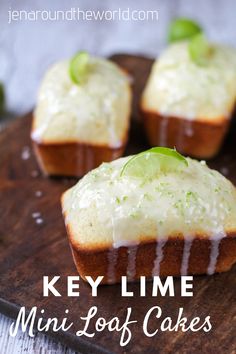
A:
[62,148,236,284]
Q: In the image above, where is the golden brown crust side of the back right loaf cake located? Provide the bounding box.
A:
[141,108,230,159]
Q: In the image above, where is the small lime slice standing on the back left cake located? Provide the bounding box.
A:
[69,52,89,84]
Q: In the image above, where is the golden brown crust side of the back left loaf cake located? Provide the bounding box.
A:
[33,141,126,177]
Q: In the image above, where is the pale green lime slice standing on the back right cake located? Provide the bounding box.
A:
[188,33,212,65]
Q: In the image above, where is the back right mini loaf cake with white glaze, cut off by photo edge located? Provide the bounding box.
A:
[141,41,236,158]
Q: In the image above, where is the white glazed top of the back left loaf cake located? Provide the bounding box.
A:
[31,56,131,147]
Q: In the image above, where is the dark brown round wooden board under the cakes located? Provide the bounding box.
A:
[0,55,236,354]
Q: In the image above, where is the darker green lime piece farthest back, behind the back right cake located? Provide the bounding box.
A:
[168,17,202,43]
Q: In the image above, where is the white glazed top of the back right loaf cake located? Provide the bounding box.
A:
[142,41,236,122]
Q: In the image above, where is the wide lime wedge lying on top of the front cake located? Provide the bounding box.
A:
[121,147,188,179]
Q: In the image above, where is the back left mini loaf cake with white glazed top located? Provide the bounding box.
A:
[31,56,131,176]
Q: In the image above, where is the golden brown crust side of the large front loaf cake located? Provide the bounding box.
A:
[64,218,236,284]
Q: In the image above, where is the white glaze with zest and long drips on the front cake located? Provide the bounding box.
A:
[65,158,236,281]
